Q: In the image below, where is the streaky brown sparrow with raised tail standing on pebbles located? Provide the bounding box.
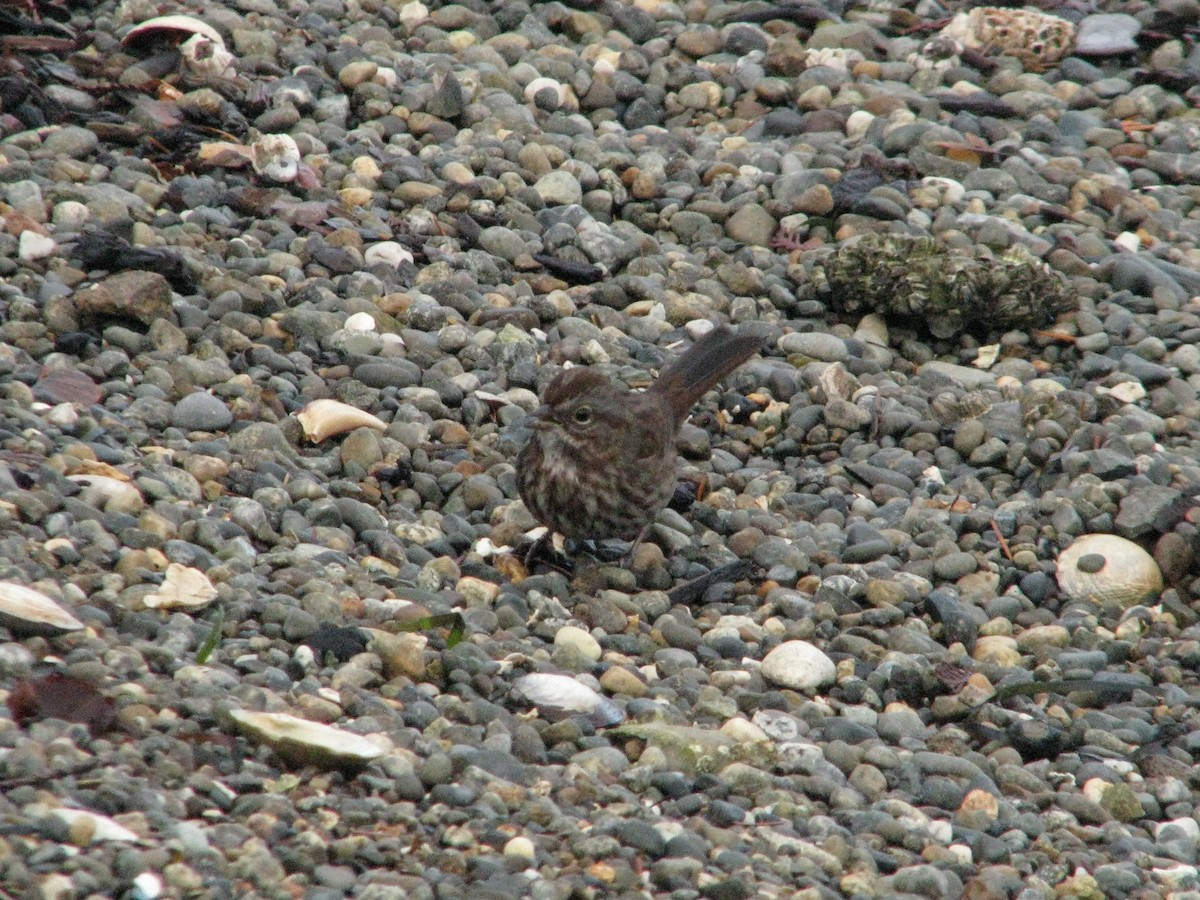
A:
[517,325,763,540]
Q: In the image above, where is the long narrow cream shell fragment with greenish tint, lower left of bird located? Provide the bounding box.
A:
[229,709,391,770]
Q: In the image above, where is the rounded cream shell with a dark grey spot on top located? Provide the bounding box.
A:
[1058,534,1163,606]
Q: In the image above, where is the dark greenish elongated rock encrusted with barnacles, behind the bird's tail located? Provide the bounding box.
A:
[804,234,1072,337]
